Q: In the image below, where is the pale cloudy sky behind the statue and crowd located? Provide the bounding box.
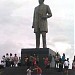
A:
[0,0,75,68]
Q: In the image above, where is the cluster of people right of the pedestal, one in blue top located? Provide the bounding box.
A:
[55,53,70,74]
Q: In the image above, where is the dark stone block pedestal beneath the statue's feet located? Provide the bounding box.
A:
[21,48,55,66]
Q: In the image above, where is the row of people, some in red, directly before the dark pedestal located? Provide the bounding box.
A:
[24,54,52,68]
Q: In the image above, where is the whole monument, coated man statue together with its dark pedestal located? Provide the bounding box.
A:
[21,0,55,65]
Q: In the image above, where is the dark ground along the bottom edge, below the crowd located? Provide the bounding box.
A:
[0,67,75,75]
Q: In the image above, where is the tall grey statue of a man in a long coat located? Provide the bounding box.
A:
[32,0,52,48]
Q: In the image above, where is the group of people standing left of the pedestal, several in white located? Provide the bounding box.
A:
[1,53,21,67]
